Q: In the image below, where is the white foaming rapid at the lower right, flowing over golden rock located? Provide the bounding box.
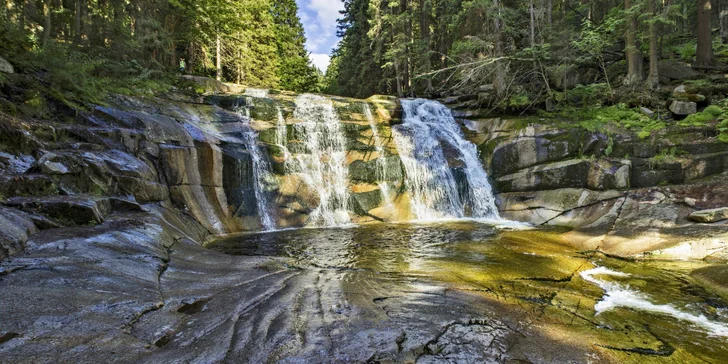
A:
[581,267,728,337]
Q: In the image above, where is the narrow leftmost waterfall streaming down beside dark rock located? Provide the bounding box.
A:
[236,104,276,231]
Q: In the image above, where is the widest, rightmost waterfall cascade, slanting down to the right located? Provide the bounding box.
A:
[393,99,500,220]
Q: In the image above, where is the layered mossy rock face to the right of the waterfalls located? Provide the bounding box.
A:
[463,110,728,259]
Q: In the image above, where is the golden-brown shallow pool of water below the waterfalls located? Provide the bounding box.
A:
[209,222,728,363]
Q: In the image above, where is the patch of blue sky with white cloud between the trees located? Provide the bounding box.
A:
[296,0,344,72]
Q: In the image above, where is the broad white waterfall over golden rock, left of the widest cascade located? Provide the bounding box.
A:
[293,95,351,227]
